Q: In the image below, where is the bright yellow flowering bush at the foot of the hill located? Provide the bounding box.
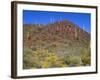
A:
[33,49,68,68]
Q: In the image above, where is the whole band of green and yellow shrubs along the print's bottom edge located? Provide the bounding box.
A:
[23,48,91,69]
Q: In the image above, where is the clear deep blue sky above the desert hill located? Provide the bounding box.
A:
[23,10,91,32]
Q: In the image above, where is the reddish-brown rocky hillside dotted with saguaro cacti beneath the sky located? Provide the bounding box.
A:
[23,20,90,66]
